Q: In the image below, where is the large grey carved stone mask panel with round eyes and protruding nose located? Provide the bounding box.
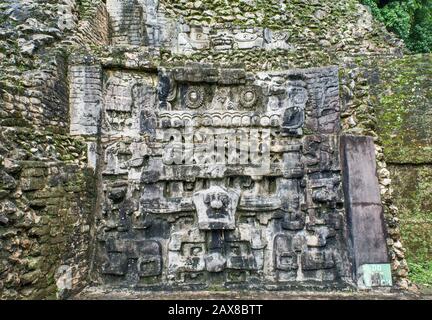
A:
[68,65,351,288]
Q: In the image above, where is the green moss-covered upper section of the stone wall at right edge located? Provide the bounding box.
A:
[375,55,432,163]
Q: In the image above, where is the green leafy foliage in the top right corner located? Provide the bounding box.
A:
[361,0,432,52]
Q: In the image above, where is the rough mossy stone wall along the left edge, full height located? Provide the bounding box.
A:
[0,1,95,299]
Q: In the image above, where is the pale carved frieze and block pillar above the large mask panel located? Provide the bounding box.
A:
[107,0,294,55]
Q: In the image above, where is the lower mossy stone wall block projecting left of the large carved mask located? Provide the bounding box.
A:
[0,127,94,299]
